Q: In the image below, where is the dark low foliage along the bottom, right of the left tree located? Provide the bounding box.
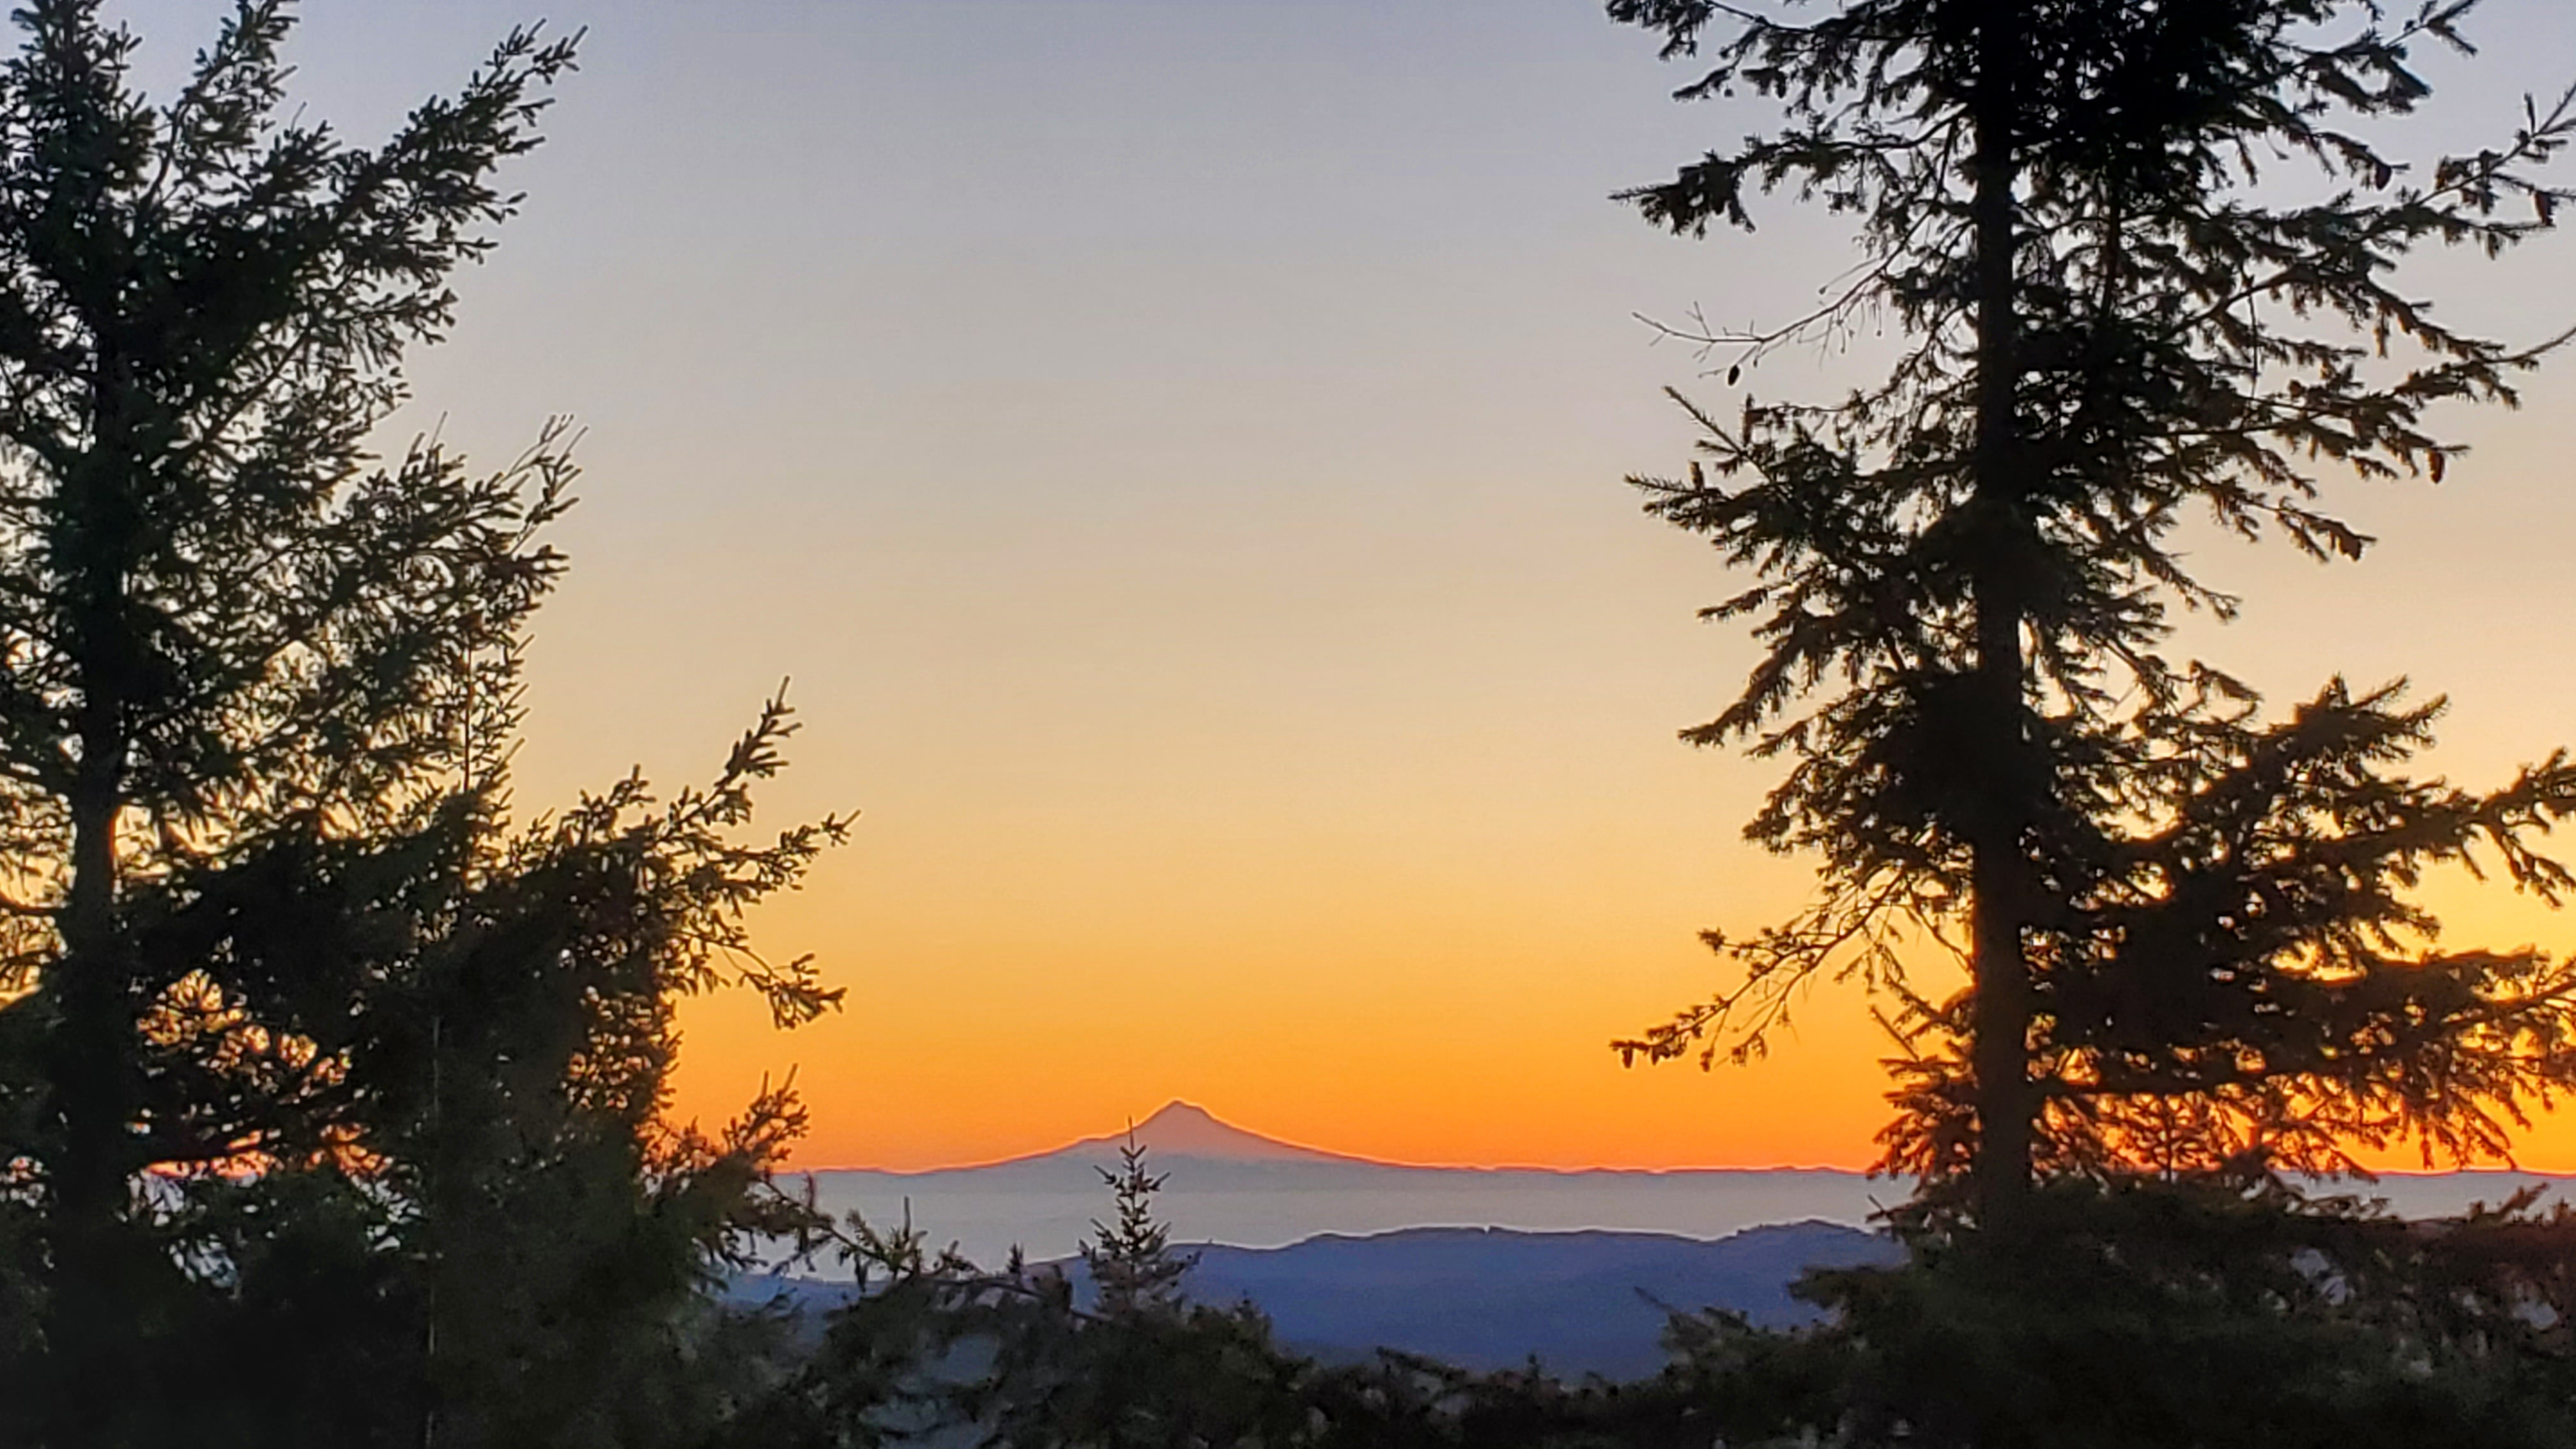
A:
[719,1165,2576,1449]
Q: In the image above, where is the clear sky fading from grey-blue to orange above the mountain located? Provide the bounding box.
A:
[111,0,2576,1170]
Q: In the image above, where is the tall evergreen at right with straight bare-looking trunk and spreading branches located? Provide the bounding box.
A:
[1607,0,2576,1225]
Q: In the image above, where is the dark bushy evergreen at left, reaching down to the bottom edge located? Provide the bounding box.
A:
[0,0,839,1446]
